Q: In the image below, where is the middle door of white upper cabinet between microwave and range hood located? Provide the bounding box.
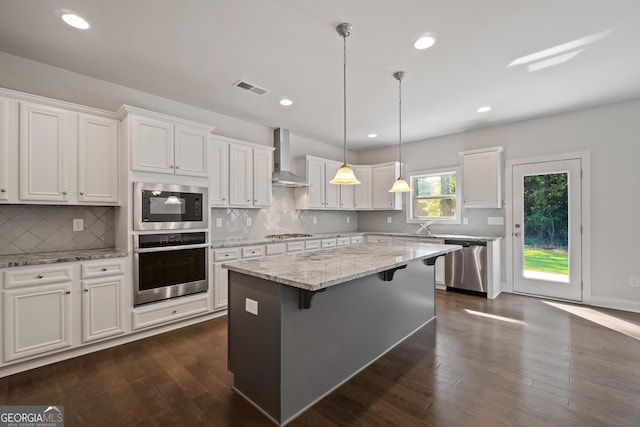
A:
[229,145,253,207]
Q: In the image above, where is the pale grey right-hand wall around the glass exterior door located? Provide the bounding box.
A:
[358,99,640,312]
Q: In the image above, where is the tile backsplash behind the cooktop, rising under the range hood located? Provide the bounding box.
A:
[211,187,358,240]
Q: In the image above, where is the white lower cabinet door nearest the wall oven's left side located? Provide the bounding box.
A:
[82,276,124,342]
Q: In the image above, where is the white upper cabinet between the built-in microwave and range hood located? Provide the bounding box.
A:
[222,138,273,208]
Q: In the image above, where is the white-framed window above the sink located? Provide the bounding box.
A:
[407,168,460,224]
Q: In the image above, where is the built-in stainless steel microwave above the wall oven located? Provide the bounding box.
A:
[133,182,209,230]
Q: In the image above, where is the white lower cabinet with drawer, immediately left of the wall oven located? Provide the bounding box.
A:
[80,262,125,342]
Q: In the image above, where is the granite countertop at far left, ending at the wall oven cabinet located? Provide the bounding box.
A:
[0,248,128,268]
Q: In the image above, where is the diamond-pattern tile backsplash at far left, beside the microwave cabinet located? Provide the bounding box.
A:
[0,205,114,255]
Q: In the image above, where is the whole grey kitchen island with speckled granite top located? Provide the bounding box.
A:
[223,243,460,425]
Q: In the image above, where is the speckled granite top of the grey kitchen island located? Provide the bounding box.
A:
[222,242,461,291]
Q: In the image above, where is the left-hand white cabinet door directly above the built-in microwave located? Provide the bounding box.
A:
[131,116,175,174]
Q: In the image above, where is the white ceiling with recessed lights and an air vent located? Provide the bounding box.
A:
[0,0,640,149]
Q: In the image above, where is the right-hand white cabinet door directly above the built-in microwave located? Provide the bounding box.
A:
[174,125,209,177]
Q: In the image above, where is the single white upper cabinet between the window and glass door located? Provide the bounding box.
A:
[459,147,504,208]
